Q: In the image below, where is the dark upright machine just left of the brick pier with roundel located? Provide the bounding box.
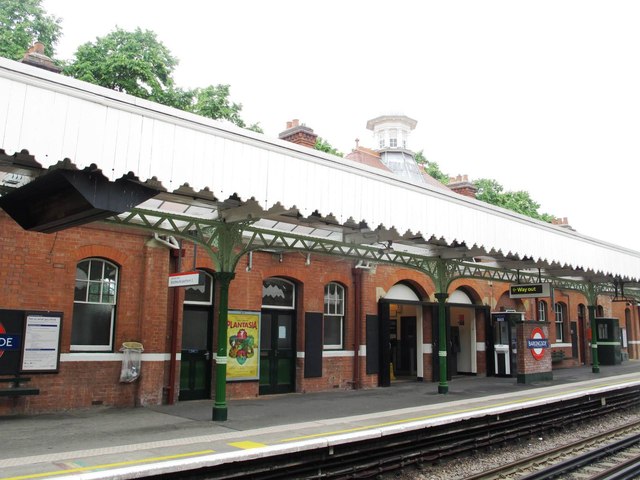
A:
[488,312,524,377]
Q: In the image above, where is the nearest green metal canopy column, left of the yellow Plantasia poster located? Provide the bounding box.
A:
[211,272,236,422]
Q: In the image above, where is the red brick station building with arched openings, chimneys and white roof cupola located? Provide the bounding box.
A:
[0,117,640,415]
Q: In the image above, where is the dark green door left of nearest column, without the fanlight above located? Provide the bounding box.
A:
[179,305,211,400]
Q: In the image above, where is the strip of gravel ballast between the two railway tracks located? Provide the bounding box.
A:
[379,408,640,480]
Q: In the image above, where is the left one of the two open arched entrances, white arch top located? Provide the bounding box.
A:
[381,283,424,380]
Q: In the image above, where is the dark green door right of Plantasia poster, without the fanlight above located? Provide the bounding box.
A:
[260,310,296,395]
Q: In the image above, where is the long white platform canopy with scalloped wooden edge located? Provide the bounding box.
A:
[0,59,640,292]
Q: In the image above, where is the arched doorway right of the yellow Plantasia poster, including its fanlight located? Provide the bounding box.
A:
[259,277,296,395]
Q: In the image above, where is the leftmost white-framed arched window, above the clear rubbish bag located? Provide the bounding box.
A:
[71,258,118,352]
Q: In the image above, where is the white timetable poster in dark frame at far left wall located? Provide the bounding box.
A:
[22,313,62,372]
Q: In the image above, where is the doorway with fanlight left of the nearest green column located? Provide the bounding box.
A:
[178,272,213,400]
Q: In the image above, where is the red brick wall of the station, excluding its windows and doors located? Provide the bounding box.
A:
[0,211,640,415]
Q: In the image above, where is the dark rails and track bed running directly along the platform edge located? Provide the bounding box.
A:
[156,387,640,480]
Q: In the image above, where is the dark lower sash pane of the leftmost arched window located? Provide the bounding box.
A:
[71,303,114,347]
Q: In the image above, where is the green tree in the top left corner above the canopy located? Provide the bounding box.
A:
[0,0,61,60]
